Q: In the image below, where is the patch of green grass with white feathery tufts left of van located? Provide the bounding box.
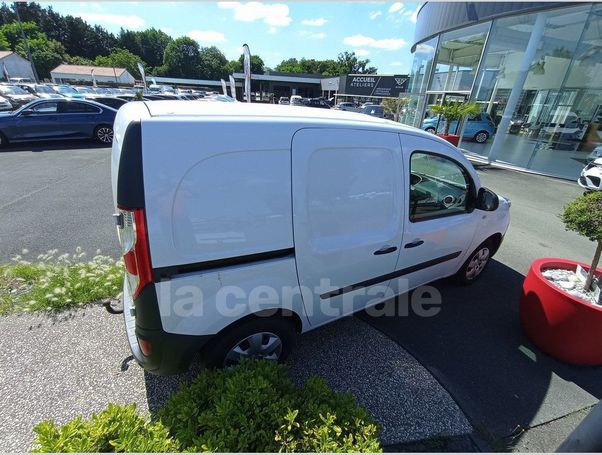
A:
[0,247,123,314]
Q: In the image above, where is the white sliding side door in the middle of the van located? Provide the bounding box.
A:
[292,128,404,326]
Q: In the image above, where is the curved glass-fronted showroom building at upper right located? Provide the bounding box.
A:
[402,2,602,179]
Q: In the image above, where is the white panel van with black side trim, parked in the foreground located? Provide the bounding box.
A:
[112,101,510,374]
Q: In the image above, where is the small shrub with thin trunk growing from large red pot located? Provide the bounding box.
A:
[560,191,602,289]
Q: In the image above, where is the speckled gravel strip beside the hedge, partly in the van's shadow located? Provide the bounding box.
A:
[0,306,472,452]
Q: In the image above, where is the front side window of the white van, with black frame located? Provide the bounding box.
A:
[410,152,470,222]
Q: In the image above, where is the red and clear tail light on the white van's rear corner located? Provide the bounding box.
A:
[115,207,152,299]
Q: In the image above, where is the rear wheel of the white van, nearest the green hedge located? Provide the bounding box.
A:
[201,316,297,368]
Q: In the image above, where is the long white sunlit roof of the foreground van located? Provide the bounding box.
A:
[145,100,418,134]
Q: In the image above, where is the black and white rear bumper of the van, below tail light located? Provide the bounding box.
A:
[123,283,212,376]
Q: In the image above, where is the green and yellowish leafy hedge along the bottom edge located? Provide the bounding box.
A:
[34,361,381,452]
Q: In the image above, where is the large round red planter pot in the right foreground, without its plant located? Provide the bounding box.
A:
[520,258,602,365]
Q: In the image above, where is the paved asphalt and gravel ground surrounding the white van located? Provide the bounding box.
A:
[0,142,602,451]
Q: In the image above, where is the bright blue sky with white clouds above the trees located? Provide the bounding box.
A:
[42,1,421,74]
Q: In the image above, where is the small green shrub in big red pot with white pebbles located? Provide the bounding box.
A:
[520,192,602,365]
